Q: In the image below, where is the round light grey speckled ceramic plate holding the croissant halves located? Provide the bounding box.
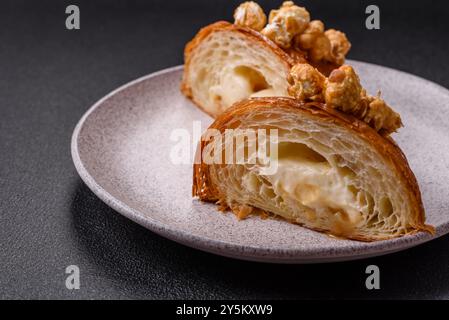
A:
[72,61,449,263]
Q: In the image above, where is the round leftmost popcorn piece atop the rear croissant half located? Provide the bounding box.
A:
[234,1,267,31]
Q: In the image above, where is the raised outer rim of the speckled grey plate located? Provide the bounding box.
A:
[71,60,449,264]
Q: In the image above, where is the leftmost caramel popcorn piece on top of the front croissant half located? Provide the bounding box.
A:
[288,63,326,101]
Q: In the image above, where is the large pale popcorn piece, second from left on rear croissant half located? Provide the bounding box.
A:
[261,1,310,49]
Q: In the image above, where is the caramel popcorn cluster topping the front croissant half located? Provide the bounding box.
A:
[289,63,402,135]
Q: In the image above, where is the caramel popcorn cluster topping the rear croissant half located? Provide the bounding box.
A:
[234,1,351,65]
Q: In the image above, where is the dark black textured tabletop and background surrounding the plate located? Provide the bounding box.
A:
[0,0,449,299]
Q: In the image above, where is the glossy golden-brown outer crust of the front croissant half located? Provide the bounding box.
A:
[192,97,435,241]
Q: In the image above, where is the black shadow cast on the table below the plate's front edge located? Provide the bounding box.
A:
[71,181,449,299]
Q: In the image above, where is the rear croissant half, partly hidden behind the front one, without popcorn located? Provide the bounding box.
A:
[181,21,339,117]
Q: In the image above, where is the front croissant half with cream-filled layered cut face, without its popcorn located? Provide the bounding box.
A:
[193,97,433,241]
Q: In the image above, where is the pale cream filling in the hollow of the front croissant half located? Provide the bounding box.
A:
[238,142,362,229]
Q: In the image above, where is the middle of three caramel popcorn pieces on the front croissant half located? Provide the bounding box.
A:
[324,65,365,116]
